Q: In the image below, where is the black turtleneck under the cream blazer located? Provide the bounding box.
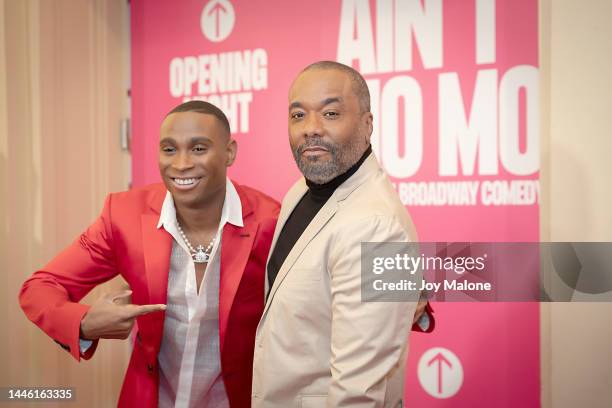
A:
[268,146,372,288]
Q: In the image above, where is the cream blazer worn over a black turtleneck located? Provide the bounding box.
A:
[252,154,416,408]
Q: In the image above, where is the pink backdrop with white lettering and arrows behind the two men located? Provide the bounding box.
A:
[131,0,540,408]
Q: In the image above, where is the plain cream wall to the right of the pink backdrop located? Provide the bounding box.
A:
[540,0,612,408]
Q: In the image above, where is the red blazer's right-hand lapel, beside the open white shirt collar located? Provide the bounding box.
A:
[219,183,259,352]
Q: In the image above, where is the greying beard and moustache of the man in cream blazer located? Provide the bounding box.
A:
[291,136,365,184]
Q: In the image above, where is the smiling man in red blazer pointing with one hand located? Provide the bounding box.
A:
[19,101,279,407]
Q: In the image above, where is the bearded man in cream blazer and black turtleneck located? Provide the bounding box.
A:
[252,61,426,408]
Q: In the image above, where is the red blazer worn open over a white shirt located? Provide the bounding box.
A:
[19,183,279,408]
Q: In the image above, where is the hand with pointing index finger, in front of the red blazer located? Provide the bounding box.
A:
[81,290,166,340]
